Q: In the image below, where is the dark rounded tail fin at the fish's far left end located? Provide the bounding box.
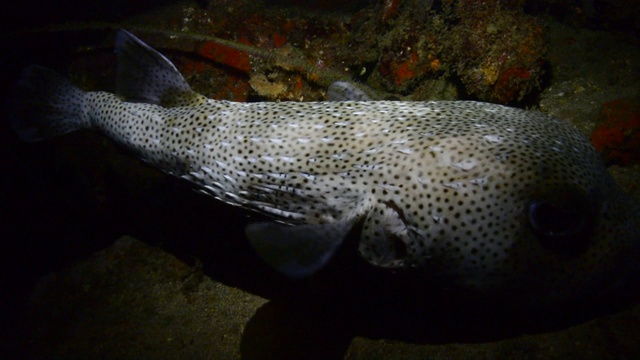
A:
[12,65,89,142]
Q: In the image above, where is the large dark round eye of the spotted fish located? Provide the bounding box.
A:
[527,186,595,256]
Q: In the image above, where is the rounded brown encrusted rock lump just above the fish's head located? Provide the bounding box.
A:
[443,0,547,103]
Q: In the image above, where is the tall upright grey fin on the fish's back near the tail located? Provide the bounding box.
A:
[115,30,206,107]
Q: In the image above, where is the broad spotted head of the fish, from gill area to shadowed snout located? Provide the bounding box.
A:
[360,107,640,304]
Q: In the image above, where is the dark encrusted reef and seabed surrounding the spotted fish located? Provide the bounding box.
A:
[0,0,640,359]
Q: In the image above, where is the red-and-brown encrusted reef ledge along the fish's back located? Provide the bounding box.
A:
[58,0,546,103]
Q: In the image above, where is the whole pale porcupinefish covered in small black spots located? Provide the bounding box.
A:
[13,30,640,304]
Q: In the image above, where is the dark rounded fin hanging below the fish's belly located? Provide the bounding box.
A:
[245,220,353,278]
